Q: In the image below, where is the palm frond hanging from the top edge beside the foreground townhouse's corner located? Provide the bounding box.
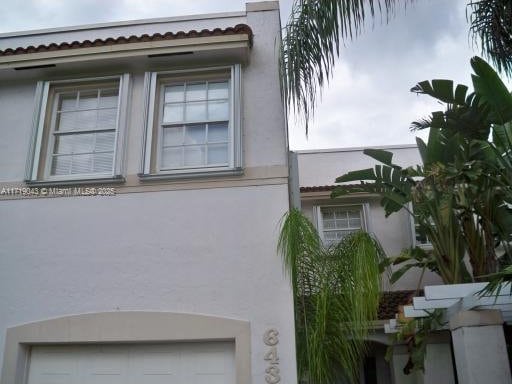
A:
[280,0,414,134]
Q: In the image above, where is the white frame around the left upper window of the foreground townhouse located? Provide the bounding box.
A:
[25,73,130,184]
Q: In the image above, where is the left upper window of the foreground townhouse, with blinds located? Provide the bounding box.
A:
[28,77,128,182]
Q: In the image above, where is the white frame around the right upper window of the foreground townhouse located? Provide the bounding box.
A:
[139,64,242,179]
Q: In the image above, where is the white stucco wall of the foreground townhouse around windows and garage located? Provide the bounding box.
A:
[0,3,296,383]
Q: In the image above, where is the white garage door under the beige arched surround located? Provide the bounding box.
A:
[28,342,235,384]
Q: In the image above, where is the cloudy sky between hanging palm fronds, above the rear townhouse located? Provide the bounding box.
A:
[290,0,482,149]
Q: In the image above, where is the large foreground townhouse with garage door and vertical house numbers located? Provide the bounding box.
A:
[0,1,297,384]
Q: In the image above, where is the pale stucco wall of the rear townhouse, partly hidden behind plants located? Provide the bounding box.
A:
[297,145,441,290]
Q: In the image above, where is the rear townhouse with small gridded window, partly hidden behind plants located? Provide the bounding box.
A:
[291,145,454,384]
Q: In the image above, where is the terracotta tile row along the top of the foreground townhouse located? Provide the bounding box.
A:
[0,24,253,56]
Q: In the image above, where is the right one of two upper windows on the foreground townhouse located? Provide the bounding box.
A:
[142,66,241,177]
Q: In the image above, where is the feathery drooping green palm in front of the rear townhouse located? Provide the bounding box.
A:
[279,209,384,384]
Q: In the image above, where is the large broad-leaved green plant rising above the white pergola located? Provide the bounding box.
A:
[332,57,512,284]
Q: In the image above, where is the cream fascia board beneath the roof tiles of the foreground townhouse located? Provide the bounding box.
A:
[0,34,249,69]
